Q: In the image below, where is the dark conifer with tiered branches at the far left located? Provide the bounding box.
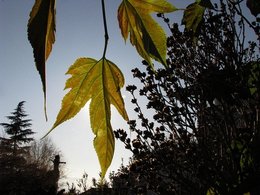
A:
[0,101,34,192]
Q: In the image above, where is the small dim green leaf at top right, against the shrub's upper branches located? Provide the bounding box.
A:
[182,1,206,33]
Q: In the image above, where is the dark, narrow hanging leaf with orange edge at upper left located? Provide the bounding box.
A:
[28,0,55,119]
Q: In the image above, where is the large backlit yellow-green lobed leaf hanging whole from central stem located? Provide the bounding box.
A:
[45,58,128,178]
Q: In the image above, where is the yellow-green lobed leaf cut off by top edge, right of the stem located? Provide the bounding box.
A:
[118,0,177,65]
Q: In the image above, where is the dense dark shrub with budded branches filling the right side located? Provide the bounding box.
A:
[113,1,260,195]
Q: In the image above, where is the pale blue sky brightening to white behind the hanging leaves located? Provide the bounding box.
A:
[0,0,192,186]
